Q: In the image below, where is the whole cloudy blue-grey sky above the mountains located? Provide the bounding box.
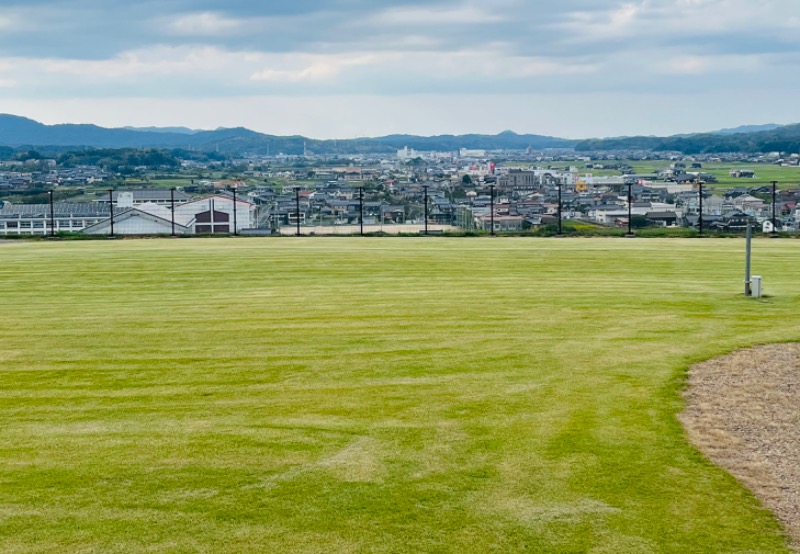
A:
[0,0,800,139]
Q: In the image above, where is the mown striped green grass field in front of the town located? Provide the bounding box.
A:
[0,237,800,554]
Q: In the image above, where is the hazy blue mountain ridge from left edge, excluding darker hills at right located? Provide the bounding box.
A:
[0,114,577,155]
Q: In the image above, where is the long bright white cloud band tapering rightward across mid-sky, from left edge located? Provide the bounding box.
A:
[0,43,599,94]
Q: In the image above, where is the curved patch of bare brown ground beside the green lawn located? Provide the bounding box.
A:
[681,343,800,551]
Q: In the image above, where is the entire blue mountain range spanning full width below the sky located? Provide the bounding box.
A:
[0,114,800,155]
